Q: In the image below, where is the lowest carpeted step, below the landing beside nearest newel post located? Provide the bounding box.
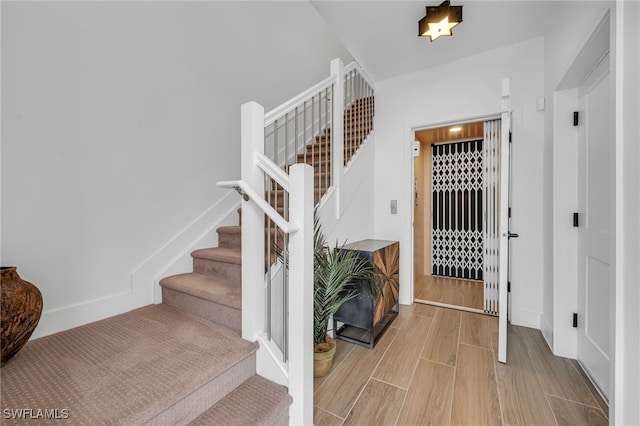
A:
[189,376,293,426]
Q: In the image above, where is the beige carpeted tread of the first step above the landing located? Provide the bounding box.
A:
[160,272,242,309]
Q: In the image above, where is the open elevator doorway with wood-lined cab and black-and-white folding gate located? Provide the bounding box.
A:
[414,121,484,313]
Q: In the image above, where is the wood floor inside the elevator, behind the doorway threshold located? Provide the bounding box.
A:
[414,275,484,310]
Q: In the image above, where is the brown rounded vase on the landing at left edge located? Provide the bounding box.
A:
[0,266,42,365]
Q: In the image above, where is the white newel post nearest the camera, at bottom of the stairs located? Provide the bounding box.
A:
[286,164,313,425]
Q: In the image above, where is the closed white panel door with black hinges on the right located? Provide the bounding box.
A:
[578,56,615,398]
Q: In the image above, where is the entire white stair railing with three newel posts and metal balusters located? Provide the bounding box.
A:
[218,59,373,424]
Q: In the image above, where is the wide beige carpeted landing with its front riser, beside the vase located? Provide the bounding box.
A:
[1,305,258,425]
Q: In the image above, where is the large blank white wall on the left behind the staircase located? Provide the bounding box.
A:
[1,2,350,336]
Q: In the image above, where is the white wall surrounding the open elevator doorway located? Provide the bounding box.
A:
[374,38,544,328]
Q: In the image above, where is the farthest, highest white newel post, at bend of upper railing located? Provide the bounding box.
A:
[331,58,344,219]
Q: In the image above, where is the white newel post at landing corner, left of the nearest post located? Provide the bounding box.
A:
[240,102,265,342]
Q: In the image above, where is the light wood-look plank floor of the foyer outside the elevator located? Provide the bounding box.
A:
[314,304,608,426]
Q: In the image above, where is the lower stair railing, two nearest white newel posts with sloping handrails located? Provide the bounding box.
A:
[218,102,313,424]
